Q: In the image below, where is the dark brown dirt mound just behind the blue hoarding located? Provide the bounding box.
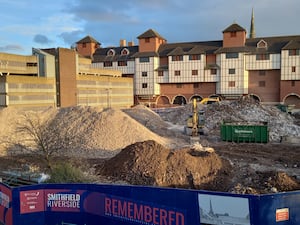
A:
[97,141,229,189]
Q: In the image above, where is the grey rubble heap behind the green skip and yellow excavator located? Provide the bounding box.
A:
[159,100,300,142]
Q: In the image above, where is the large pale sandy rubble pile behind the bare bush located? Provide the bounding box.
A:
[0,106,168,158]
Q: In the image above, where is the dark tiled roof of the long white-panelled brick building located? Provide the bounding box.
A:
[94,28,300,62]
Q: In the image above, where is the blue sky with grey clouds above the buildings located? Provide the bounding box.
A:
[0,0,300,55]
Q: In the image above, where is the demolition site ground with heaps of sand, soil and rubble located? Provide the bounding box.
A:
[0,100,300,194]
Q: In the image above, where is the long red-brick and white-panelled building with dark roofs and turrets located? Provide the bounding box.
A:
[88,22,300,108]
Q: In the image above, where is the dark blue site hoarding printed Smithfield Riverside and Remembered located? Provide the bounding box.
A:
[0,184,300,225]
